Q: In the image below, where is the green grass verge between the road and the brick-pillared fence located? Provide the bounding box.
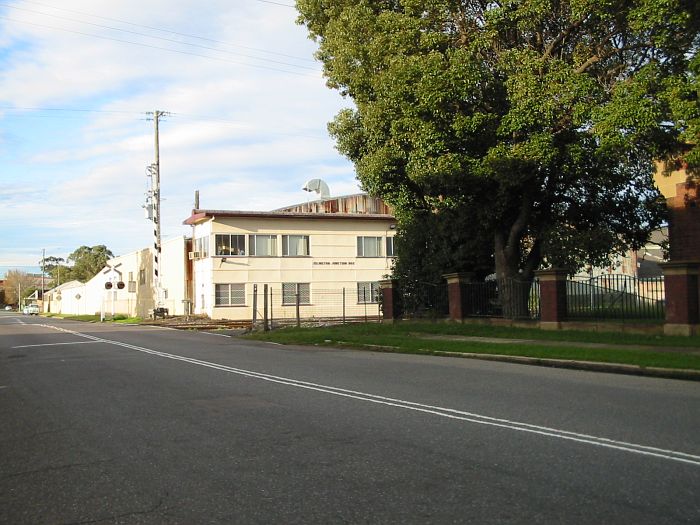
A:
[247,322,700,370]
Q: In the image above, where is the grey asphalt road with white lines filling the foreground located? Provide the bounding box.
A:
[0,312,700,524]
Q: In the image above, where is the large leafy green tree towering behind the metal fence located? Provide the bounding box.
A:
[297,0,700,304]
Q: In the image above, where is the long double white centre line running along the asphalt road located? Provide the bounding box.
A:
[38,325,700,467]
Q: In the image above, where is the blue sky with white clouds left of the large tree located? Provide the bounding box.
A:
[0,0,360,275]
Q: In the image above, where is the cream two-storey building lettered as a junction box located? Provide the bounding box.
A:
[185,195,396,320]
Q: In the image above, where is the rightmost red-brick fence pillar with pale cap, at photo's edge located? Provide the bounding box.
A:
[660,261,700,335]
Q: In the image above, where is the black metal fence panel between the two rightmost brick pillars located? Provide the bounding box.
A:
[566,274,665,320]
